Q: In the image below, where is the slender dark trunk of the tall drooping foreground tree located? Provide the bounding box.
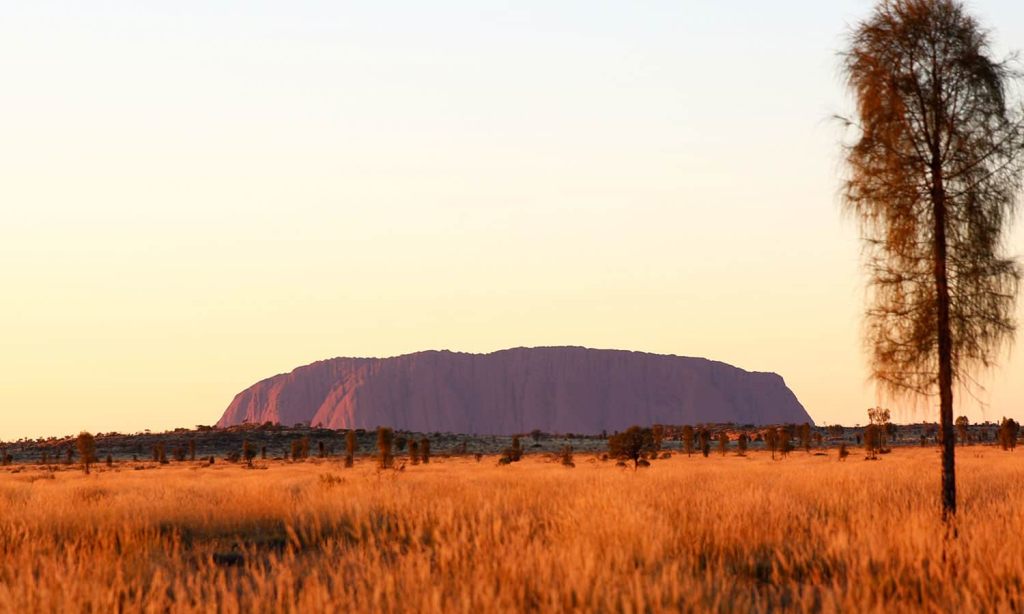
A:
[932,159,956,521]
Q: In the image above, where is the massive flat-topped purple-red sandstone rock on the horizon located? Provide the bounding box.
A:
[217,347,813,435]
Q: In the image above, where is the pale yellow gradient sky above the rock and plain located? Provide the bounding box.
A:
[0,0,1024,439]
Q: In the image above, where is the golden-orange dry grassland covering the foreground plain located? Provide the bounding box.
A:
[0,446,1024,612]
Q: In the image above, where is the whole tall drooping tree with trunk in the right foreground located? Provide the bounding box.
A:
[844,0,1024,518]
